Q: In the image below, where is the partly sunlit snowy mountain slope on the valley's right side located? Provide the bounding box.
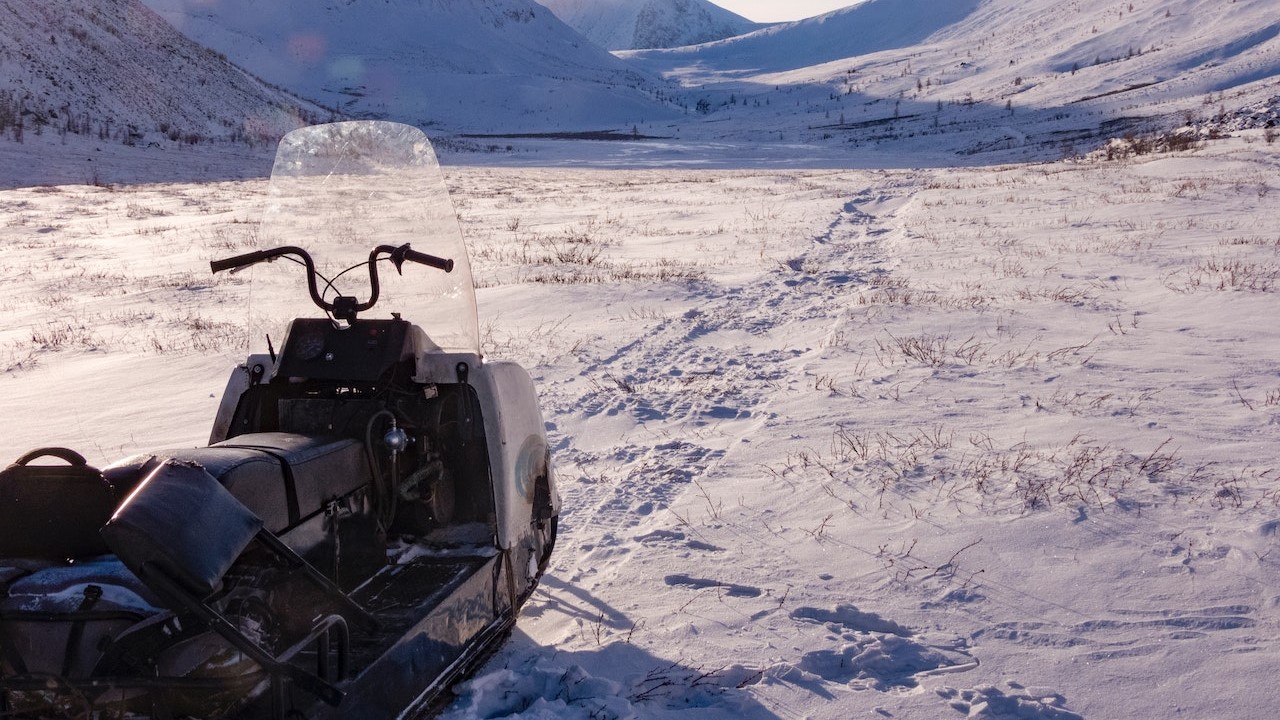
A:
[618,0,1280,156]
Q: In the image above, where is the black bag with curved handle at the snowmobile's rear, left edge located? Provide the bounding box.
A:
[0,447,119,560]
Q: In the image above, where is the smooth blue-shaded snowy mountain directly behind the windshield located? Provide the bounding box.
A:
[145,0,676,133]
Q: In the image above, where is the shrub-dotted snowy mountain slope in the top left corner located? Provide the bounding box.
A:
[0,0,328,143]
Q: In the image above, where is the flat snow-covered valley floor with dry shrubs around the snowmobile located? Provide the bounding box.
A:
[0,131,1280,719]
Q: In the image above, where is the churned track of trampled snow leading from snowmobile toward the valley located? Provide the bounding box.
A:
[553,170,911,563]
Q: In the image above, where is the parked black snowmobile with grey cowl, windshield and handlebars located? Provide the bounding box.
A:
[0,122,561,720]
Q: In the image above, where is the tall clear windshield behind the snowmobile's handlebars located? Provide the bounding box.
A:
[250,122,480,352]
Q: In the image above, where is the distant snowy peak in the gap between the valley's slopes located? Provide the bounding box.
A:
[539,0,764,50]
